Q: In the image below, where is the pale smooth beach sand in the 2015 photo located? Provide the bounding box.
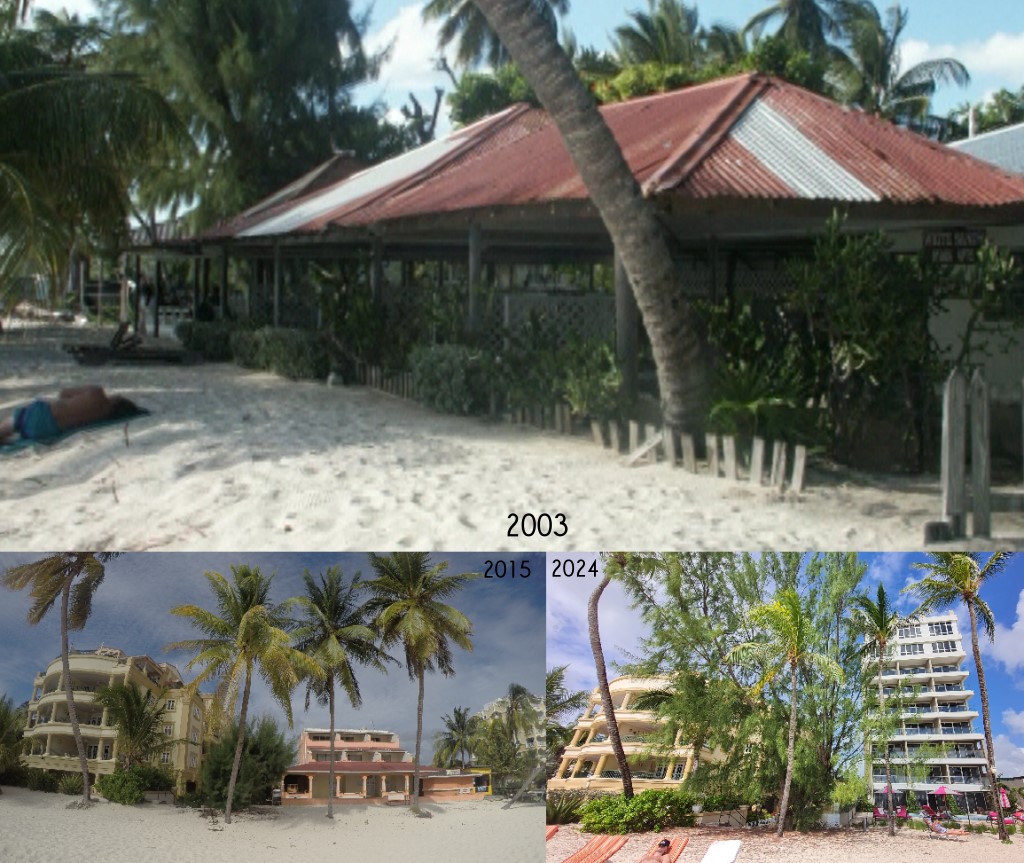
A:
[0,787,544,863]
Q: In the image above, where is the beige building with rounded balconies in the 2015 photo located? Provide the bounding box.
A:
[22,647,214,792]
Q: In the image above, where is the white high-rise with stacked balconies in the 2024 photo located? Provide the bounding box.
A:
[865,612,988,812]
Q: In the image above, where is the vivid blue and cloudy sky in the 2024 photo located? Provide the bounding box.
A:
[548,553,1024,776]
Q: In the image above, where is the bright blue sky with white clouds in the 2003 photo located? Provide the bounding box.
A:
[34,0,1024,131]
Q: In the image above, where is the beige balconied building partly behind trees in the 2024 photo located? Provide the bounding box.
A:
[548,676,698,793]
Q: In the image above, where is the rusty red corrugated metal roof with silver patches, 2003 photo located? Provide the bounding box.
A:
[216,74,1024,235]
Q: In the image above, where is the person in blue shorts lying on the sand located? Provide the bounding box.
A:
[0,386,139,443]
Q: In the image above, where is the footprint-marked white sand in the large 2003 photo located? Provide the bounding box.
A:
[0,327,1024,551]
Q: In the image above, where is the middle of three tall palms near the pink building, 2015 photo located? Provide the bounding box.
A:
[293,566,390,818]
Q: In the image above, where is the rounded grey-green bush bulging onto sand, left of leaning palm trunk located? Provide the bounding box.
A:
[410,345,486,415]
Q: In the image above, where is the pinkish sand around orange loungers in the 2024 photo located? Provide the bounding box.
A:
[547,824,1024,863]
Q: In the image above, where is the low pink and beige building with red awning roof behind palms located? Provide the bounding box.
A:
[281,728,489,806]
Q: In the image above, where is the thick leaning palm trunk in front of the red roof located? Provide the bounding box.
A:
[474,0,703,430]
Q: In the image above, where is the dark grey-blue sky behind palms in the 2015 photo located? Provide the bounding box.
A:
[0,552,545,759]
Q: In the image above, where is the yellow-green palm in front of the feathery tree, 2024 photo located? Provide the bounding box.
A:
[729,588,843,836]
